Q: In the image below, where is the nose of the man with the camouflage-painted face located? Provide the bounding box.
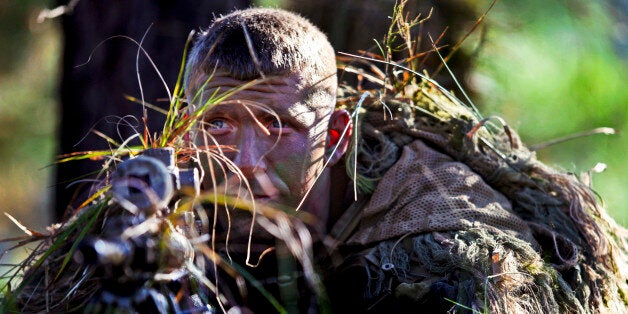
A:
[232,131,267,179]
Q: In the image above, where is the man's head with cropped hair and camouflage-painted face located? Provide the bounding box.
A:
[185,8,350,311]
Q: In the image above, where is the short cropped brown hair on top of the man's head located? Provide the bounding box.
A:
[185,8,337,110]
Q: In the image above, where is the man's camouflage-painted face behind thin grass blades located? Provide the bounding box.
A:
[191,73,348,218]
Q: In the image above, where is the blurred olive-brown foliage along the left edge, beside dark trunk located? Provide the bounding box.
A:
[0,0,56,282]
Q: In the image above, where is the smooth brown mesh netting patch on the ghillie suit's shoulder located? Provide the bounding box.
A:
[348,140,534,244]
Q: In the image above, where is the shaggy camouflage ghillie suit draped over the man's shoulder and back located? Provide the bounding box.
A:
[328,82,628,313]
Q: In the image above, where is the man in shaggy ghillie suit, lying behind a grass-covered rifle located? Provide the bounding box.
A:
[186,9,626,313]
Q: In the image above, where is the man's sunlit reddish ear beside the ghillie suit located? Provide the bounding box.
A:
[325,109,353,166]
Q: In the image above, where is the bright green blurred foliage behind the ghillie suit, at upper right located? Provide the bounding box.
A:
[467,0,628,225]
